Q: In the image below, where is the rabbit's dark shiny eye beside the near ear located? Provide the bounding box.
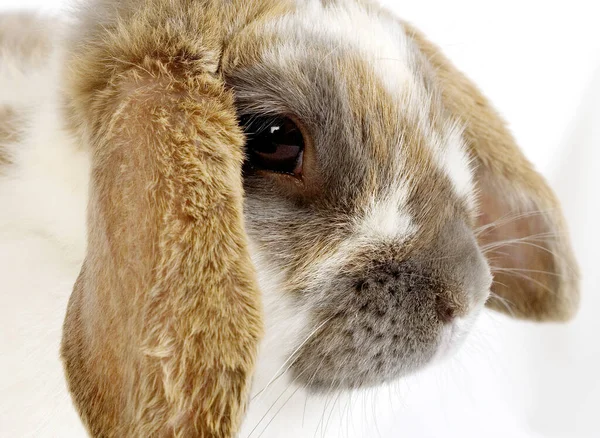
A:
[241,116,304,176]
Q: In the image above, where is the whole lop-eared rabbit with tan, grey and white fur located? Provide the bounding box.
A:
[0,0,579,437]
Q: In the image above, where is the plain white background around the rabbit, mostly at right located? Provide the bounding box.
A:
[0,0,600,438]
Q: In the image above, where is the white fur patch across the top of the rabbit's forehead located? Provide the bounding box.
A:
[274,0,414,96]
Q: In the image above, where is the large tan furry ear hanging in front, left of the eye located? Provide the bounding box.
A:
[62,0,262,437]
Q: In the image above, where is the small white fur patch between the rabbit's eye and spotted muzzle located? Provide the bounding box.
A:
[356,186,416,240]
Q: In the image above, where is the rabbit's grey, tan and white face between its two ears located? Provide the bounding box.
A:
[223,2,491,391]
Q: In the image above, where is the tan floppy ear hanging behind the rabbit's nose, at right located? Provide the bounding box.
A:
[405,25,579,321]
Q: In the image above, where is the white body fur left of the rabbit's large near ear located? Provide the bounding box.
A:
[0,38,89,437]
